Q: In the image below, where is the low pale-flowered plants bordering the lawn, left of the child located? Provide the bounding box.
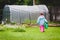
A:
[0,24,29,32]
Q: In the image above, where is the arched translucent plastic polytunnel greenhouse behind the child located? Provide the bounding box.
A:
[2,5,48,24]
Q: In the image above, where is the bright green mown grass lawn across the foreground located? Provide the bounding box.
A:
[0,27,60,40]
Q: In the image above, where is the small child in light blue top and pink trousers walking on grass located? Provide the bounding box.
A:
[37,12,47,32]
